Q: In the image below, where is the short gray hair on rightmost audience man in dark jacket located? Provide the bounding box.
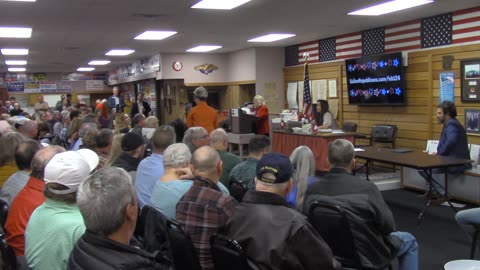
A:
[328,139,355,168]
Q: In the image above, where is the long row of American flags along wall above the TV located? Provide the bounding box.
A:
[285,7,480,66]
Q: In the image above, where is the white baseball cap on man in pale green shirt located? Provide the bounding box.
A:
[44,148,99,194]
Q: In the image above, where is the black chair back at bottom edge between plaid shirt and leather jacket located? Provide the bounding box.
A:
[210,234,259,270]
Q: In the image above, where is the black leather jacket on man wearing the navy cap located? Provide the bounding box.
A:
[222,191,339,270]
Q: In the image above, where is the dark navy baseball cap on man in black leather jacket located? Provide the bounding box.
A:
[257,153,293,184]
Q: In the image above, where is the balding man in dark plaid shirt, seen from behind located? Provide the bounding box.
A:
[176,146,237,270]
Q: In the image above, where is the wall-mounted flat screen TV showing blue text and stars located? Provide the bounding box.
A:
[345,53,406,105]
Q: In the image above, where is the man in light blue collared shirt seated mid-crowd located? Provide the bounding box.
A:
[135,125,175,208]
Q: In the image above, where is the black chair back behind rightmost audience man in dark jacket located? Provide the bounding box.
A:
[308,201,360,267]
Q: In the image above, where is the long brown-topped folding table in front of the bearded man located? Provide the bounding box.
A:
[355,146,472,224]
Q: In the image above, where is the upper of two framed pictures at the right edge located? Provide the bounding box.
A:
[460,59,480,102]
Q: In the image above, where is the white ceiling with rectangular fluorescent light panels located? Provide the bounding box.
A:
[0,0,480,72]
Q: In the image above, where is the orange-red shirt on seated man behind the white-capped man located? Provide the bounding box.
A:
[5,177,45,256]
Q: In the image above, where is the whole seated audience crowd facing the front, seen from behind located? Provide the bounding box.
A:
[0,99,424,270]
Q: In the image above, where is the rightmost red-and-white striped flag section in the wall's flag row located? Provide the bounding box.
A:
[452,7,480,44]
